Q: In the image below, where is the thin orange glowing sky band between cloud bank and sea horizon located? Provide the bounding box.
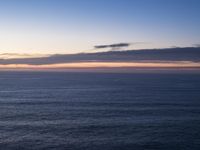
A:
[0,61,200,70]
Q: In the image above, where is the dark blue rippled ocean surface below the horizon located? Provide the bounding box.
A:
[0,72,200,150]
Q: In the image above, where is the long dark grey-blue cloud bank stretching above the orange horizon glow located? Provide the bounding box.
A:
[0,47,200,65]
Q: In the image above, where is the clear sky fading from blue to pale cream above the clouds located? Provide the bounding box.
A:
[0,0,200,54]
